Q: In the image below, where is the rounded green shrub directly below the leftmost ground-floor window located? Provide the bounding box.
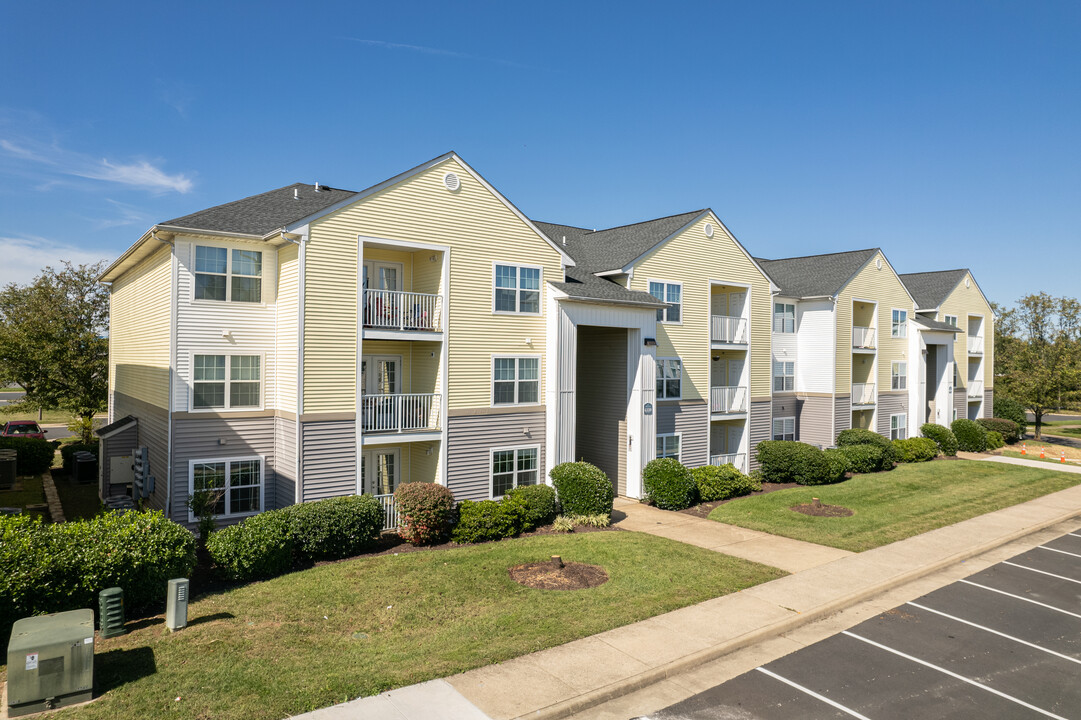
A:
[206,510,293,582]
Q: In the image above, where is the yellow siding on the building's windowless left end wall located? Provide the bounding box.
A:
[109,246,173,409]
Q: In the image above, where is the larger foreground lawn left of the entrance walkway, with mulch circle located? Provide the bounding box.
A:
[12,532,785,720]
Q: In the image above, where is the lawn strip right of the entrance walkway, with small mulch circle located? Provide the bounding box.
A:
[709,461,1081,552]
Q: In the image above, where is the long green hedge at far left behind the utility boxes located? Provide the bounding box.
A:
[0,511,196,638]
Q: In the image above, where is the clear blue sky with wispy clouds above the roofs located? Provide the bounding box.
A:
[0,0,1081,304]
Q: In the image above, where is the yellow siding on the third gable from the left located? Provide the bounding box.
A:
[837,253,915,395]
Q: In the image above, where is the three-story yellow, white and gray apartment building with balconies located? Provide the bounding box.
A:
[99,152,991,522]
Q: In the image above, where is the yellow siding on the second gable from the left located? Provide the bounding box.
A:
[628,213,772,400]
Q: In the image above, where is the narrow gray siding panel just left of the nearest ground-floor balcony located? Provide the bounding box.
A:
[301,421,357,503]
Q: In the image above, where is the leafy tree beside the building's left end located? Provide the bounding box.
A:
[0,258,109,442]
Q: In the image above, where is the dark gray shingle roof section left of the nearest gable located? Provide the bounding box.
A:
[161,183,357,236]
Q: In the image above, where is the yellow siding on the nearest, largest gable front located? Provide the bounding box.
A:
[304,158,562,413]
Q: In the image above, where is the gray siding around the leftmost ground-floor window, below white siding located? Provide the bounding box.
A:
[173,417,278,523]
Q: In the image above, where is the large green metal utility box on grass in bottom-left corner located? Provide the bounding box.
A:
[8,609,94,718]
